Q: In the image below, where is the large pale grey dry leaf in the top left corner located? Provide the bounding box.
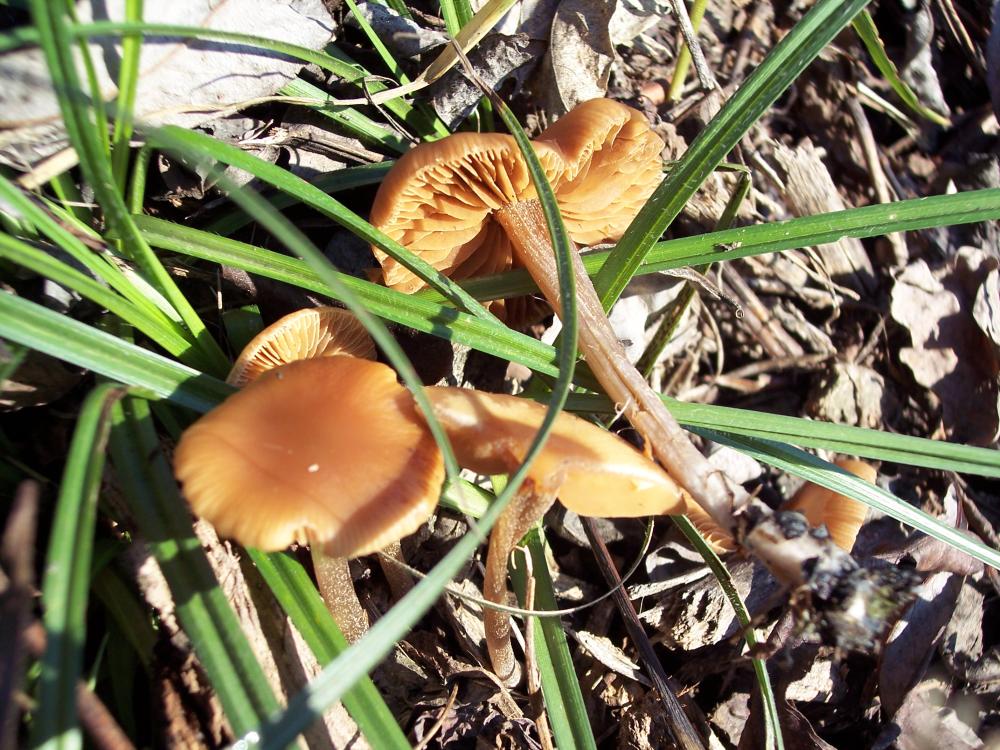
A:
[0,0,334,166]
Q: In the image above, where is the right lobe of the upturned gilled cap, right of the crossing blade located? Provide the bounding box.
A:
[535,99,663,245]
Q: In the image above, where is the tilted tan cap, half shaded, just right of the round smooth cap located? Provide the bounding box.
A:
[426,387,684,518]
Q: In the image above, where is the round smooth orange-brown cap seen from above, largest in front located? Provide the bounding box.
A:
[174,356,444,557]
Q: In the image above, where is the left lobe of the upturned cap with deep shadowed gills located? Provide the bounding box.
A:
[371,133,551,292]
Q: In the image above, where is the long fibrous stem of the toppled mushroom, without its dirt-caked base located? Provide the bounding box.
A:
[494,200,742,536]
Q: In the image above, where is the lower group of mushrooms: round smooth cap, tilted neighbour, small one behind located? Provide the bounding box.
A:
[174,311,687,684]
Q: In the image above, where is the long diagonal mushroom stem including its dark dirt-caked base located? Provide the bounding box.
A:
[491,200,913,649]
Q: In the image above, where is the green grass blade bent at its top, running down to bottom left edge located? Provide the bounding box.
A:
[32,384,125,750]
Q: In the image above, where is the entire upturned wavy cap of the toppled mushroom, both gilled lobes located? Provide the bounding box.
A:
[371,99,663,314]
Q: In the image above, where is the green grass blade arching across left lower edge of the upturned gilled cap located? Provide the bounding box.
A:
[150,127,495,320]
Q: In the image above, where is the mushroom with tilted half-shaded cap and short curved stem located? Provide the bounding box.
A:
[426,387,686,686]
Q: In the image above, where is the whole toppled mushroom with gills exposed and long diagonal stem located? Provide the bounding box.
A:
[371,99,738,560]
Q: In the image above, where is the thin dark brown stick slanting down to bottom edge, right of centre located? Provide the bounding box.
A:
[580,516,705,750]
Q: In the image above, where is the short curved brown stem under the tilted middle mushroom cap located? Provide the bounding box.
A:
[483,479,556,687]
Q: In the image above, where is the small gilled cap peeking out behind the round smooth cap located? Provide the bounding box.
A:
[226,307,375,387]
